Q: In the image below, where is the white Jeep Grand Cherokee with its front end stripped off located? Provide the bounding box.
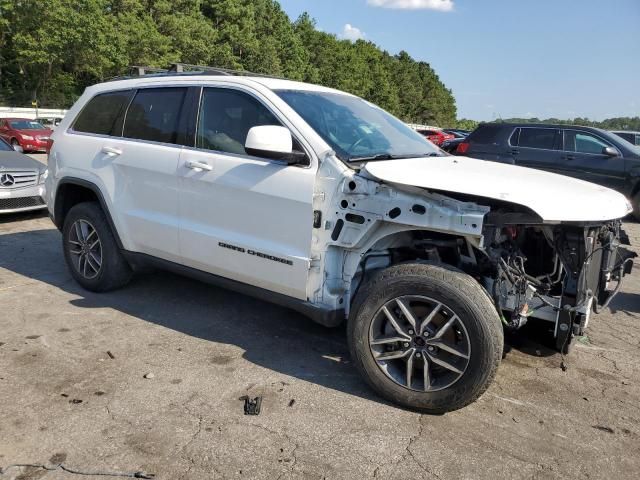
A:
[46,70,632,412]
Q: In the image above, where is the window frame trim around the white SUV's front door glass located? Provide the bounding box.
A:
[185,84,313,168]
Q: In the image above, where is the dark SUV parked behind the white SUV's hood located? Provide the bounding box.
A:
[456,123,640,218]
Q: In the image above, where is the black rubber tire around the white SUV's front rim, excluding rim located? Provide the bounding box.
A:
[347,264,504,414]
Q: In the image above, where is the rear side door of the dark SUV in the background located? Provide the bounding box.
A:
[509,127,562,172]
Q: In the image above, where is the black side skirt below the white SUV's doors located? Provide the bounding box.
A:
[122,250,344,327]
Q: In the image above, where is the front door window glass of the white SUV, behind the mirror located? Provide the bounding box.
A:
[196,88,282,155]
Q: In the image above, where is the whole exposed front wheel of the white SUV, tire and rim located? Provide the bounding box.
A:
[348,264,504,413]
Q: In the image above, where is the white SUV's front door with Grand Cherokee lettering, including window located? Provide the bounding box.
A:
[178,84,317,300]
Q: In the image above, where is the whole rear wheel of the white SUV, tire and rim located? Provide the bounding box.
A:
[62,202,132,292]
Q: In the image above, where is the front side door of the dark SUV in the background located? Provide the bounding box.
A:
[558,129,626,191]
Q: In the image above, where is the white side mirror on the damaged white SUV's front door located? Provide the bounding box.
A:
[244,125,306,165]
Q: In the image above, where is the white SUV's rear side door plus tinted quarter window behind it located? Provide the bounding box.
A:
[71,87,188,261]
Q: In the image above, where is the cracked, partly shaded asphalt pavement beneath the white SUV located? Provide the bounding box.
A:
[0,198,640,480]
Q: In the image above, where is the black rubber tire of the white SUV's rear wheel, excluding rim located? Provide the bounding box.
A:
[62,202,133,292]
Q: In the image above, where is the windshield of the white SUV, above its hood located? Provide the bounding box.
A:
[276,90,443,161]
